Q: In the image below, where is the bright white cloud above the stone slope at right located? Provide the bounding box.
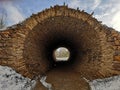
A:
[95,0,120,31]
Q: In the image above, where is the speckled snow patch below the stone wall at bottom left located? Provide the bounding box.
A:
[0,66,35,90]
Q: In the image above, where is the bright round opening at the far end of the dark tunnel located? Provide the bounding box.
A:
[53,47,70,62]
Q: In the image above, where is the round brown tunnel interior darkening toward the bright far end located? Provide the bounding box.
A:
[24,16,101,75]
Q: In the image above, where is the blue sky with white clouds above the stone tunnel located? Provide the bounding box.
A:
[0,0,120,31]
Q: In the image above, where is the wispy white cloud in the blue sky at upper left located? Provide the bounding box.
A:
[2,1,24,24]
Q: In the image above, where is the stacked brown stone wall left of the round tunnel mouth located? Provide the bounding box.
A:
[0,26,31,75]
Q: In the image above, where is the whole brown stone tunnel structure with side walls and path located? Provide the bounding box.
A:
[0,5,120,90]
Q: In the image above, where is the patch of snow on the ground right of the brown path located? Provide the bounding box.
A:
[89,76,120,90]
